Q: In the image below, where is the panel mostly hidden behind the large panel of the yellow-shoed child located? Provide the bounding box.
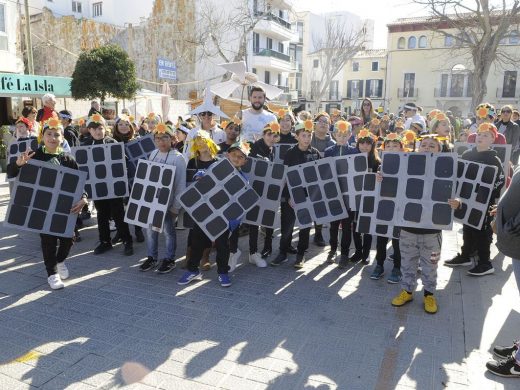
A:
[356,173,400,238]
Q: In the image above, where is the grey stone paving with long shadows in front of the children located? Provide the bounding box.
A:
[0,175,520,390]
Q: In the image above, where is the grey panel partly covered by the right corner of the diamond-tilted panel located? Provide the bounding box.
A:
[242,158,287,228]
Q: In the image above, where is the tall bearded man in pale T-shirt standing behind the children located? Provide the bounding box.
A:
[240,87,277,142]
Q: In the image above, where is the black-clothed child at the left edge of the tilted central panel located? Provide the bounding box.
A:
[271,120,320,268]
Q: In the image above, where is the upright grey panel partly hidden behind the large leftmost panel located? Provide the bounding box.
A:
[71,142,128,200]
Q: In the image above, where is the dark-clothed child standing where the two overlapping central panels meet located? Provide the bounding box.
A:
[325,120,359,268]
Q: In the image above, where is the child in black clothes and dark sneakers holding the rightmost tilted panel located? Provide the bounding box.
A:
[444,122,505,276]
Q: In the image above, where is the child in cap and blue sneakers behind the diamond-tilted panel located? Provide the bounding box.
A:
[177,140,249,287]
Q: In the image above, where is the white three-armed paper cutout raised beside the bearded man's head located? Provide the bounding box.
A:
[211,61,283,100]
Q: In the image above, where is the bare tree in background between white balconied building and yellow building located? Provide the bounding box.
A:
[311,18,366,107]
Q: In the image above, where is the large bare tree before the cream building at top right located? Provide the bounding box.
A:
[414,0,520,107]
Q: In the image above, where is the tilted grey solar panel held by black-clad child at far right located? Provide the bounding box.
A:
[454,160,498,229]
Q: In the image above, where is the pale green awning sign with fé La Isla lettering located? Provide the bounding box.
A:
[0,73,72,97]
